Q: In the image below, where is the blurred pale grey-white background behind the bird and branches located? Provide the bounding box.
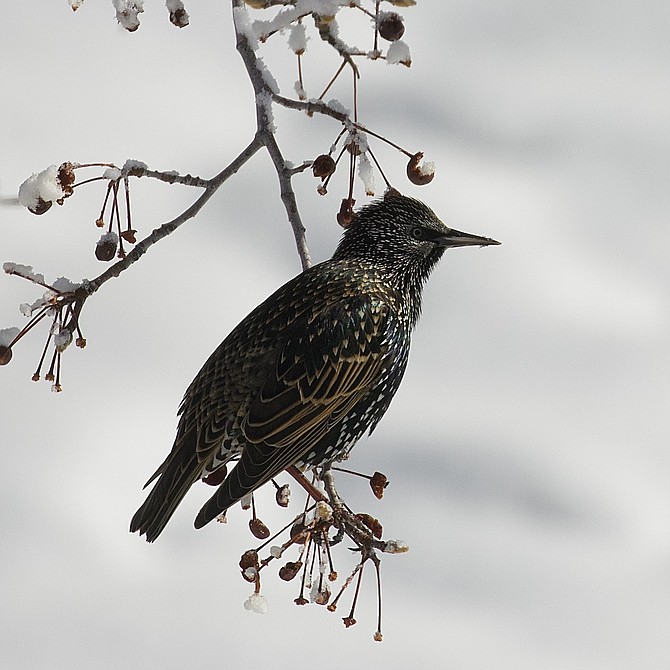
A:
[0,0,670,670]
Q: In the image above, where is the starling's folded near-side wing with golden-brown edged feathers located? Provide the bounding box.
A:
[196,299,390,527]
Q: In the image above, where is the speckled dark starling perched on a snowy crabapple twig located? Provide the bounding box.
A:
[130,190,500,542]
